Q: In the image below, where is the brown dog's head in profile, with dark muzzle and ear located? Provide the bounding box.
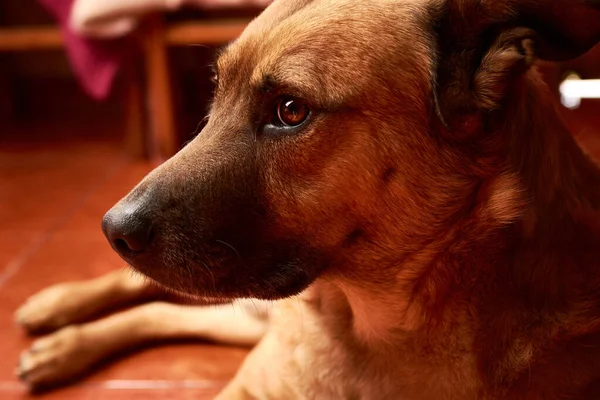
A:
[103,0,600,299]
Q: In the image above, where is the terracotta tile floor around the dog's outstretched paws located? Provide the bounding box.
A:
[0,121,246,400]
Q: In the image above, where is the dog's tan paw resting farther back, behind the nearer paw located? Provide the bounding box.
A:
[15,282,101,333]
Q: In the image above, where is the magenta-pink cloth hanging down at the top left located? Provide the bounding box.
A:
[39,0,125,100]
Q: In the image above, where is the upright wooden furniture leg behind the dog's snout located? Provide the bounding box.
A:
[143,15,178,161]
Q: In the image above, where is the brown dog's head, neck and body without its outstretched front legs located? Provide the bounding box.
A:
[12,0,600,400]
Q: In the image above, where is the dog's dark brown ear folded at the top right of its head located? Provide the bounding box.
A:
[434,0,600,134]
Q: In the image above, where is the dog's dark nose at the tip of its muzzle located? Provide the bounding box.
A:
[102,204,152,257]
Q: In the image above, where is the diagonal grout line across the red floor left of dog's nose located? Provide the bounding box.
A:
[0,156,127,291]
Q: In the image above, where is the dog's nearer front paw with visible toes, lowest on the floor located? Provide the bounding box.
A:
[17,326,103,389]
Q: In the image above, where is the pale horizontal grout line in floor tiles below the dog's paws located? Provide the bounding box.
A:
[0,379,229,392]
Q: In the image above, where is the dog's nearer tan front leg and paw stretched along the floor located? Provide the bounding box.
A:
[18,302,266,389]
